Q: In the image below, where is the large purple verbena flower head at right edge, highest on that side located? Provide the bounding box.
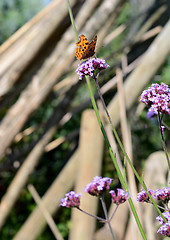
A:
[140,83,170,117]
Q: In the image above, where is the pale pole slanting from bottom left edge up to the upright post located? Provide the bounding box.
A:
[13,150,80,240]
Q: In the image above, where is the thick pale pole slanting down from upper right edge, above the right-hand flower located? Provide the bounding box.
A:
[108,21,170,126]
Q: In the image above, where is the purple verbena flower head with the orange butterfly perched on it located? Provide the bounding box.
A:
[76,58,109,80]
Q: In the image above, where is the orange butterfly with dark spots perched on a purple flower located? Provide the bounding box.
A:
[74,35,97,60]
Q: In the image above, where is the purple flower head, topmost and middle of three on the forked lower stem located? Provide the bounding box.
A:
[84,176,113,196]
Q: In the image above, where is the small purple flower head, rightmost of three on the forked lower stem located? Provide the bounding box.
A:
[109,188,130,205]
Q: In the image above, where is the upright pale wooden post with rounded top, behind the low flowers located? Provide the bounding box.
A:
[69,110,104,240]
